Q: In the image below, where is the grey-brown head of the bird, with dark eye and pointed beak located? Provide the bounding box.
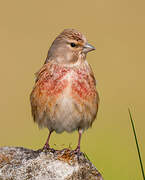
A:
[45,29,95,64]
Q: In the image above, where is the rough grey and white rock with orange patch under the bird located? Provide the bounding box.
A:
[0,147,103,180]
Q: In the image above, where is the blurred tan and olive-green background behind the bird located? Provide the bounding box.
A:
[0,0,145,180]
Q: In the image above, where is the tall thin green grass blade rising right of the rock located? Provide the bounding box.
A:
[128,108,145,180]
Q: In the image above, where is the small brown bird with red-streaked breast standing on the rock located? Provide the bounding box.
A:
[30,29,99,152]
